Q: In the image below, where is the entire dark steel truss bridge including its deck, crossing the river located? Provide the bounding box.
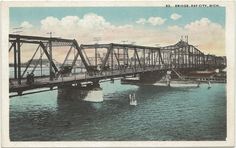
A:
[9,34,226,95]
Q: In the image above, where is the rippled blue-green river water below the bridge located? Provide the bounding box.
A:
[10,80,226,141]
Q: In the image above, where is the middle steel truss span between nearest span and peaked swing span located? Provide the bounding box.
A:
[81,43,163,72]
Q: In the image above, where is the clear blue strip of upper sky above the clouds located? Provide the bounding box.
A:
[10,7,225,27]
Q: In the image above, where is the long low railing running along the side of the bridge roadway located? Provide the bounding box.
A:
[10,64,212,88]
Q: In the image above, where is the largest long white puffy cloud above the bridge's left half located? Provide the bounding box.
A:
[40,13,122,38]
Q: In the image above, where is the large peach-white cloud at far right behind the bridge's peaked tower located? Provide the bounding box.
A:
[166,18,225,55]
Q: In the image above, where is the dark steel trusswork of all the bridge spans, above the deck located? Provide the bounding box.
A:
[9,34,226,84]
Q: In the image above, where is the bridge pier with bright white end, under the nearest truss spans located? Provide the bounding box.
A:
[57,81,103,102]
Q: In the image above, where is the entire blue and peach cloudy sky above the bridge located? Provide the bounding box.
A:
[10,7,225,61]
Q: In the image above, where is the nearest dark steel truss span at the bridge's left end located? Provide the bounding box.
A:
[9,34,87,84]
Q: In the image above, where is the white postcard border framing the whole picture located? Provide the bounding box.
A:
[0,0,235,147]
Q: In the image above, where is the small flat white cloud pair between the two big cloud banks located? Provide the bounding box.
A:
[136,17,166,26]
